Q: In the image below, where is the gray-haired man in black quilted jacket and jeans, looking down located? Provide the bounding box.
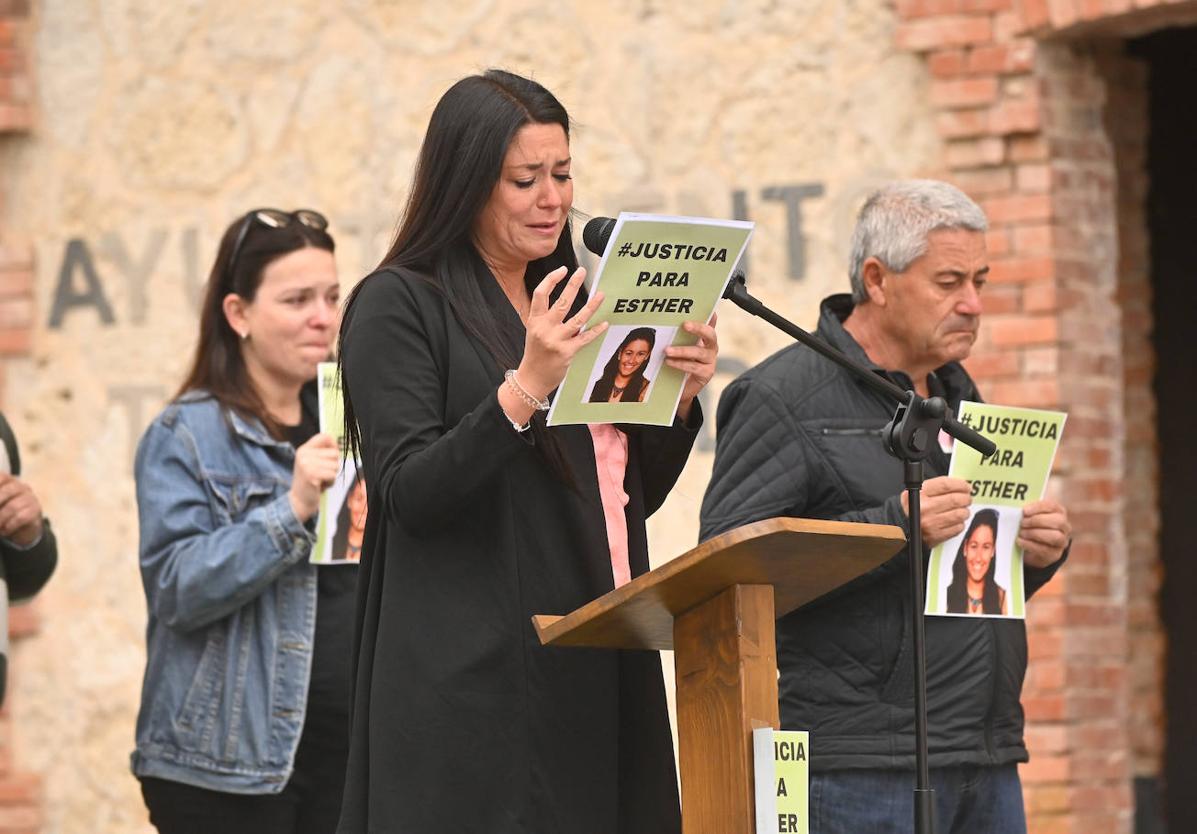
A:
[701,179,1070,834]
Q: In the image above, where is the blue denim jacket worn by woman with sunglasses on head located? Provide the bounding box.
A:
[132,392,316,793]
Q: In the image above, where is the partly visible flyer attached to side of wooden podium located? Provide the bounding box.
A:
[752,726,810,834]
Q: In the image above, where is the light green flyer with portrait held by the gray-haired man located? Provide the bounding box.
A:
[925,402,1068,619]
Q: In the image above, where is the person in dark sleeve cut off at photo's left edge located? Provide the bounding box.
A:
[0,414,59,704]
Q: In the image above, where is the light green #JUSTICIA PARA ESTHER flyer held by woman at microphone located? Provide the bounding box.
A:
[548,213,754,426]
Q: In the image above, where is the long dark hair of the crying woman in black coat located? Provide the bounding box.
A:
[339,69,585,483]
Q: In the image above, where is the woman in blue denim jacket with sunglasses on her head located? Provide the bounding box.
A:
[132,209,357,834]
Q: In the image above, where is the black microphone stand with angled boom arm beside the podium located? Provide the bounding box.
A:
[723,273,997,834]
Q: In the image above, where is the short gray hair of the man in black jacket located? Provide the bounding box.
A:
[849,179,989,304]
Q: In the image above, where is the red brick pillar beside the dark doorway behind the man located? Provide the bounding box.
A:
[895,0,1197,834]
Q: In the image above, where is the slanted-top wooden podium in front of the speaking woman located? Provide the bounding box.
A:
[533,518,906,834]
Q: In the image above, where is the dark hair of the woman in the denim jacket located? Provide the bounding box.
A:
[175,214,336,440]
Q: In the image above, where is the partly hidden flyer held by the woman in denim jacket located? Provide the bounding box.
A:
[310,363,366,565]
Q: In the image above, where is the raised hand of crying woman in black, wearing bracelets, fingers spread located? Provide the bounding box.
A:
[516,267,607,400]
